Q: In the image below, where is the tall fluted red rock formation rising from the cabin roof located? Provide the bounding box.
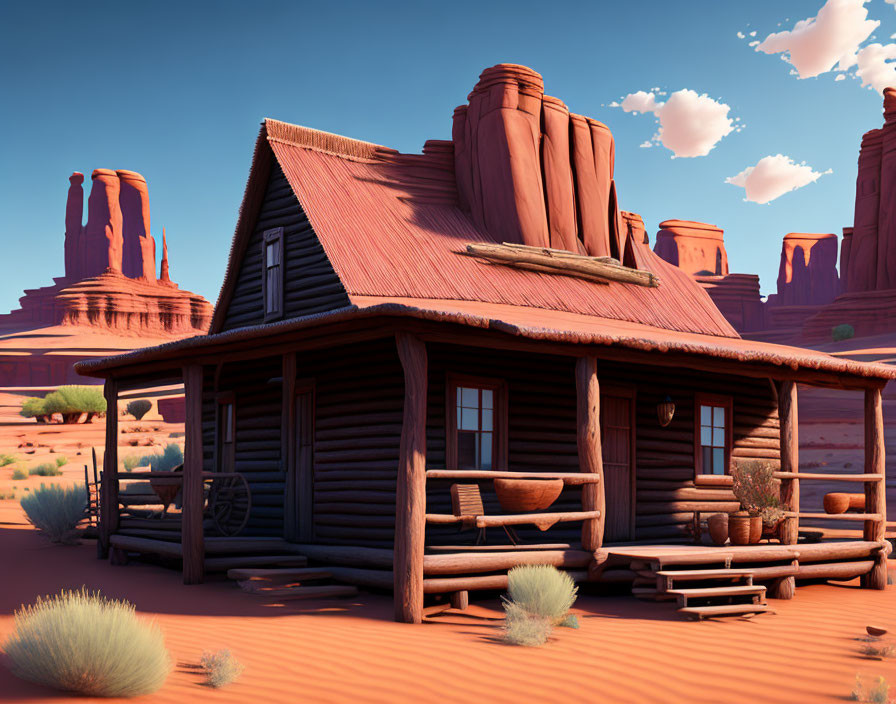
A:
[452,64,626,260]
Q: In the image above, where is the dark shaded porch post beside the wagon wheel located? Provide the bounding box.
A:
[181,364,205,584]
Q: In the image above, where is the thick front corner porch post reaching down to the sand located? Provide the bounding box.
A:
[392,332,427,623]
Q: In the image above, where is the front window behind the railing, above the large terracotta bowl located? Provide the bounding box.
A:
[446,377,507,470]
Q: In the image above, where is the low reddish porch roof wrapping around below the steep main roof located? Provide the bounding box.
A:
[75,296,896,385]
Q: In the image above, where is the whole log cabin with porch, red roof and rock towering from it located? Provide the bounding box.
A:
[78,64,896,622]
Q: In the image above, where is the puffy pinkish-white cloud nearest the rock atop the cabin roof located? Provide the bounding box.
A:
[621,88,734,157]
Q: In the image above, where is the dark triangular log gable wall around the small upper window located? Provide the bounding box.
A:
[222,160,349,330]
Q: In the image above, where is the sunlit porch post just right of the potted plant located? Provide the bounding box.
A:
[772,381,800,599]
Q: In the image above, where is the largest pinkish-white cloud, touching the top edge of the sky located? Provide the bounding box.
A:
[756,0,880,78]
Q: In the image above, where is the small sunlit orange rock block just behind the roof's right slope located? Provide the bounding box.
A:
[653,220,728,276]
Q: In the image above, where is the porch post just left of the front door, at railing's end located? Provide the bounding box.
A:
[576,356,606,552]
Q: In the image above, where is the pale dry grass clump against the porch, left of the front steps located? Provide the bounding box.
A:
[504,565,578,646]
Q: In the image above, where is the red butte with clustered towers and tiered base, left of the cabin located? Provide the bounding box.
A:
[0,169,212,337]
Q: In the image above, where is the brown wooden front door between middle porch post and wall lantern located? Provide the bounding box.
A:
[600,390,635,543]
